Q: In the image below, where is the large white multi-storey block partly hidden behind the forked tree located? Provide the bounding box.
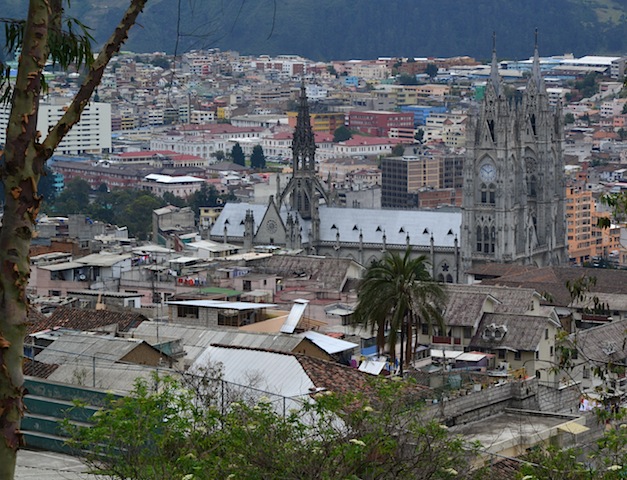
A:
[0,98,111,155]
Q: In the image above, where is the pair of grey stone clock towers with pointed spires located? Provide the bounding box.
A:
[461,33,568,278]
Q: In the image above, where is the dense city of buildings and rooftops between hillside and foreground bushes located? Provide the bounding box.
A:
[0,24,627,478]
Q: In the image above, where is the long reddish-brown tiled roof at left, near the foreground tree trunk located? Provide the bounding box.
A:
[28,307,148,334]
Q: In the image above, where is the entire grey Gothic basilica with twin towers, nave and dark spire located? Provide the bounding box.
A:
[211,42,568,283]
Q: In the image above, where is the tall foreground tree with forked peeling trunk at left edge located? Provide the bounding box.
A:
[0,0,147,479]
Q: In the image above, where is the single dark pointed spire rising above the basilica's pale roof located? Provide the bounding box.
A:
[278,83,329,221]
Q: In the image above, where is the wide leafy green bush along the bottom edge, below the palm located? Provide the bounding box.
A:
[65,378,476,480]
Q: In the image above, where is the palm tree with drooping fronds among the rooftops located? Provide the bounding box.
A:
[352,249,445,372]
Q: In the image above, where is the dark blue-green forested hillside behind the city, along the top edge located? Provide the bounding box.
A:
[3,0,627,60]
